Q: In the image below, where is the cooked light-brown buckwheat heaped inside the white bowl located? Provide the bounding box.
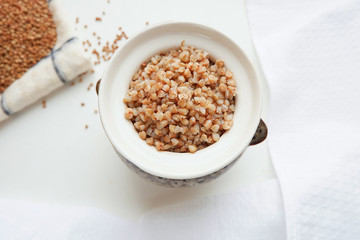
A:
[123,41,236,153]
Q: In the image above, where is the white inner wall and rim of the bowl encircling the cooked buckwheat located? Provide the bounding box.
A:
[99,23,262,179]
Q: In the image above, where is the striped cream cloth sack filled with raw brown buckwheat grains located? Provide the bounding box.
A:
[0,0,92,121]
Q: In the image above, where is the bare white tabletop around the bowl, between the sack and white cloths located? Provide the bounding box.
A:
[0,0,274,219]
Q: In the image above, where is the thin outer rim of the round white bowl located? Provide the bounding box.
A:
[98,21,263,179]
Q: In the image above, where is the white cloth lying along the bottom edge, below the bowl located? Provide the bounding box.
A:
[0,180,285,240]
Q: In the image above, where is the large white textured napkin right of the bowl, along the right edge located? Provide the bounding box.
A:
[248,0,360,240]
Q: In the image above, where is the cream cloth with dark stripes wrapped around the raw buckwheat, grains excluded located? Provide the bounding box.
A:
[0,0,92,121]
